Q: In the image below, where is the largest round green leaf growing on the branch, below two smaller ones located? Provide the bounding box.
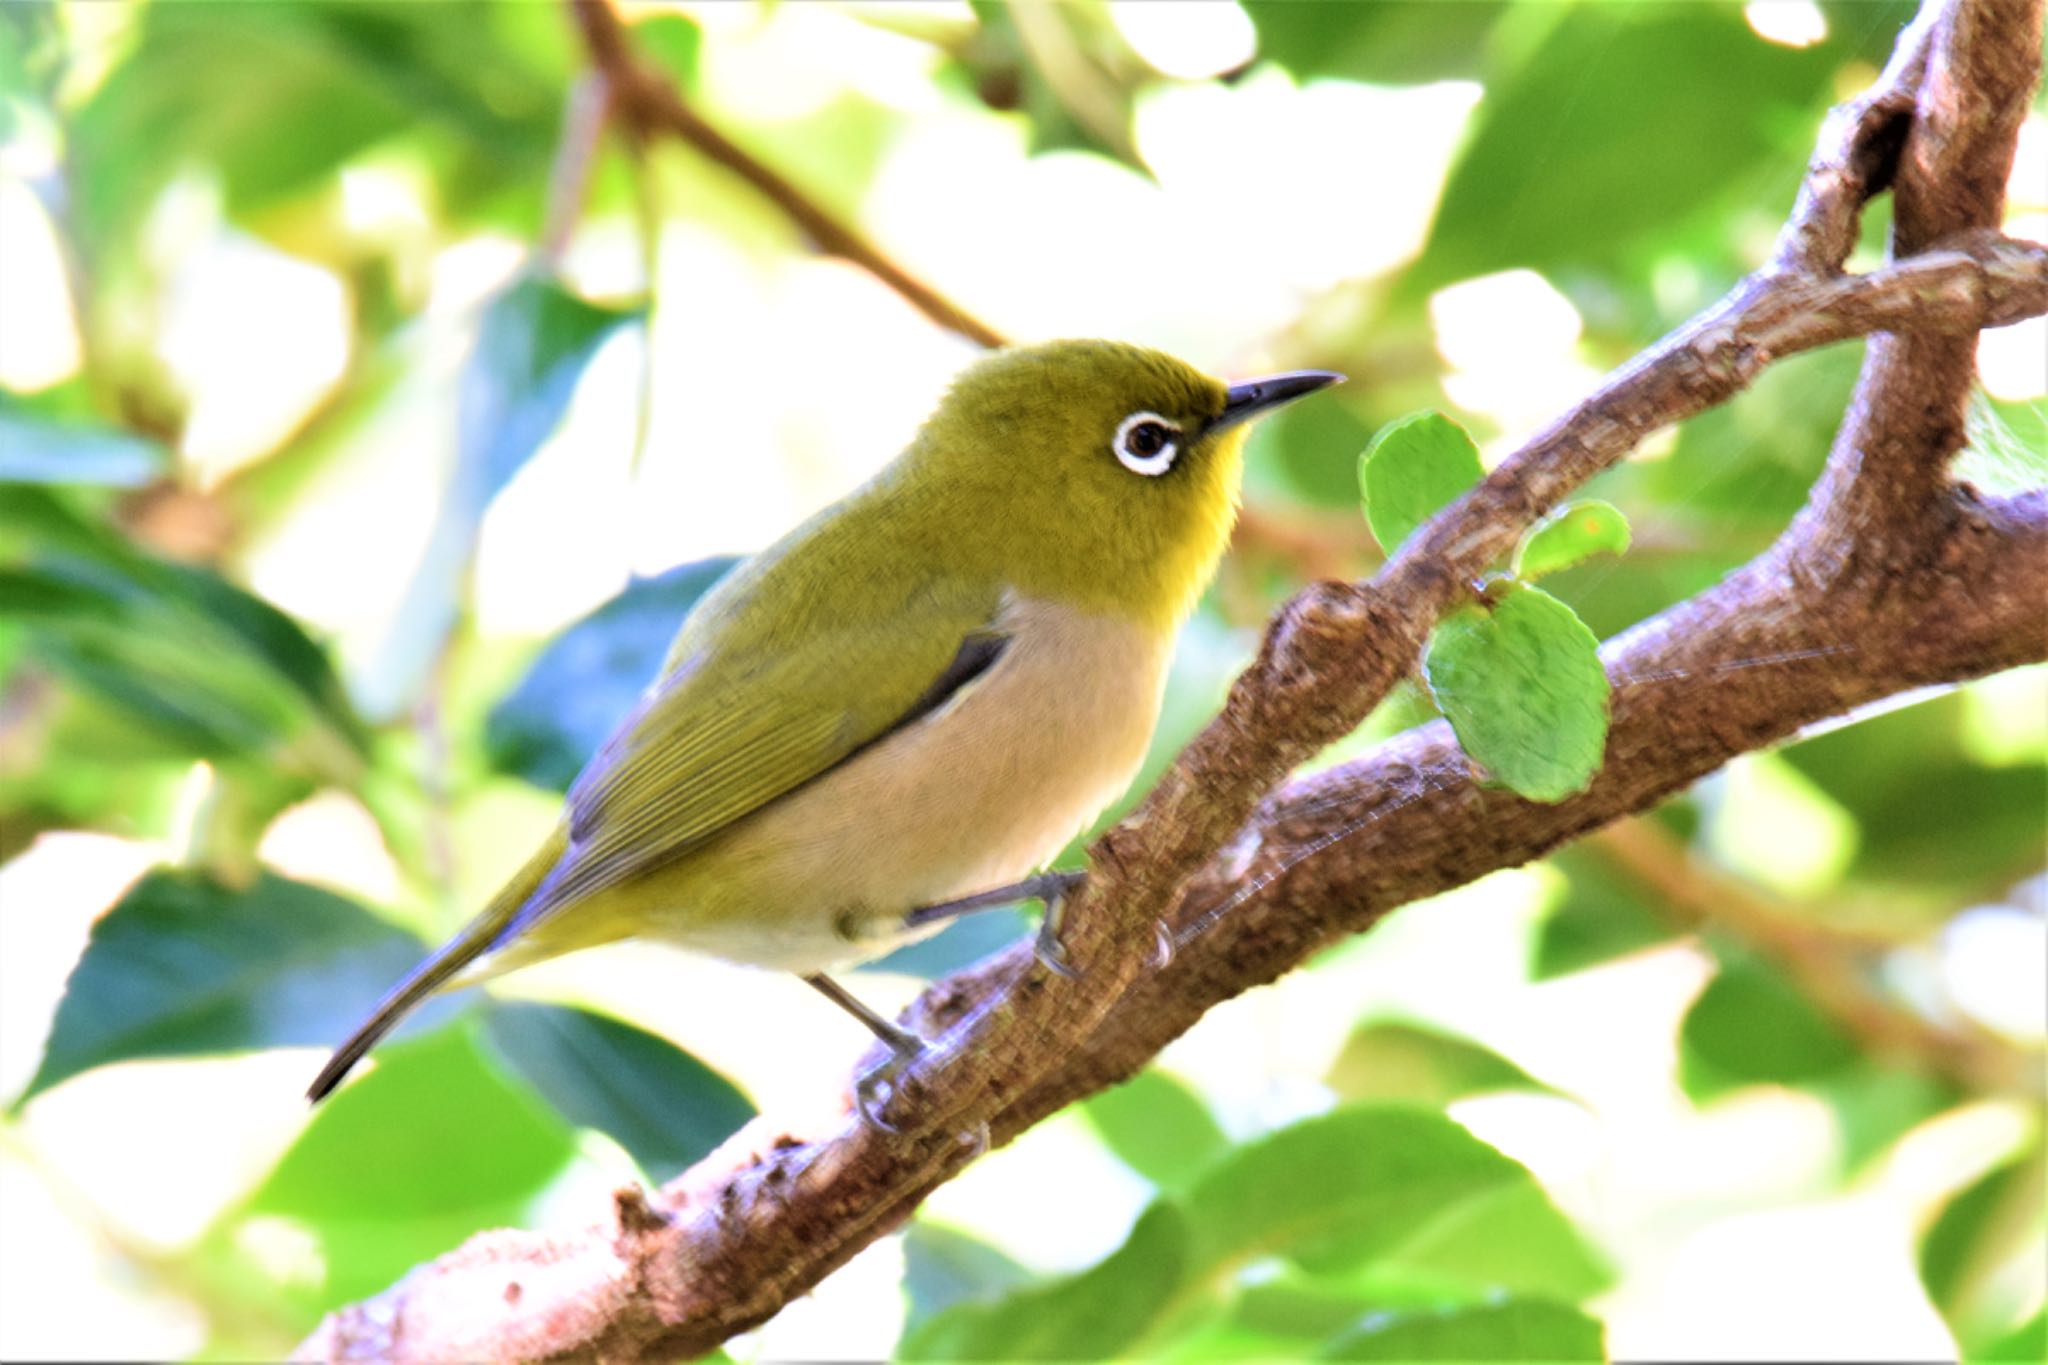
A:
[1423,581,1608,800]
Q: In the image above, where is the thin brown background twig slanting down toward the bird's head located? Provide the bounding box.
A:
[569,0,1006,348]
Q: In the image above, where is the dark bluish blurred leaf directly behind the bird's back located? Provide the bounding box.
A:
[483,557,737,792]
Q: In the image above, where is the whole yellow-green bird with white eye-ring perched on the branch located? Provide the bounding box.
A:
[307,342,1341,1113]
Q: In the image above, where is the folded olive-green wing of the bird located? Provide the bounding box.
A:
[506,593,1004,935]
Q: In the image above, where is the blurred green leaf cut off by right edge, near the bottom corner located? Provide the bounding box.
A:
[1919,1136,2048,1361]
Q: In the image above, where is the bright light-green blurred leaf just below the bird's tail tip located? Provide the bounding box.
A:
[242,1025,575,1310]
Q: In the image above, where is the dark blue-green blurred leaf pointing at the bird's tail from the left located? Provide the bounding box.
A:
[16,872,434,1103]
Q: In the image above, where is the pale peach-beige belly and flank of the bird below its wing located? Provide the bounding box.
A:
[637,602,1171,972]
